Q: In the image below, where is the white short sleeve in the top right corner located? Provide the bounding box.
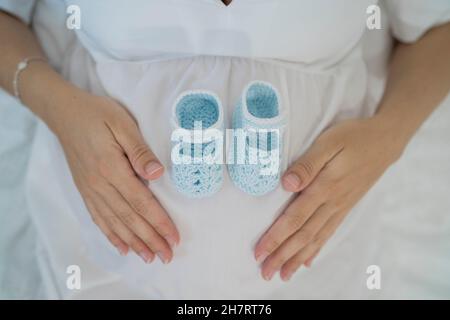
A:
[384,0,450,43]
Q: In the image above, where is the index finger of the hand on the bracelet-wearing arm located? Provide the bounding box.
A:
[110,152,180,248]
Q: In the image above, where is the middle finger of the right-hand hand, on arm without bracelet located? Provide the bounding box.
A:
[261,205,333,280]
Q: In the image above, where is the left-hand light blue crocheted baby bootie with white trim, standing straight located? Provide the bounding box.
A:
[171,91,223,198]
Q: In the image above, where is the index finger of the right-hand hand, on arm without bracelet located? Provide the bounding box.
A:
[255,190,323,262]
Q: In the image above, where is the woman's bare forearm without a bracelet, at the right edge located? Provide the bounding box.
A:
[375,23,450,152]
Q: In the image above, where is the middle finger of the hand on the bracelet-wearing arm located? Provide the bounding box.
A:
[98,181,172,263]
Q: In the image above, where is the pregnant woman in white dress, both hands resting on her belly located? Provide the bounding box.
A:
[0,0,450,299]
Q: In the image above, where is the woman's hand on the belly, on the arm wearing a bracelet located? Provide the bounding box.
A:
[54,94,179,263]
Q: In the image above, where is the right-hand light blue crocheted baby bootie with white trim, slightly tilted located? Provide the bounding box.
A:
[228,81,285,196]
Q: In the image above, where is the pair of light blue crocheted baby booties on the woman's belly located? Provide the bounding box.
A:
[171,81,285,198]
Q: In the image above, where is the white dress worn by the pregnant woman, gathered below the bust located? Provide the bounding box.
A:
[0,0,450,299]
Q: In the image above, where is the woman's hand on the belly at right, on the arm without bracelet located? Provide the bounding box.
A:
[255,116,405,280]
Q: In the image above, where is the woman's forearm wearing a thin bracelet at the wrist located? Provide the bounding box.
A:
[0,11,83,135]
